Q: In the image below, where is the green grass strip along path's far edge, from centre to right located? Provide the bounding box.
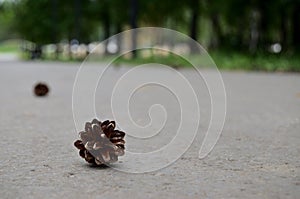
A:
[114,50,300,72]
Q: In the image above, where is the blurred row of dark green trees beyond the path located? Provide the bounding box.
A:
[9,0,300,54]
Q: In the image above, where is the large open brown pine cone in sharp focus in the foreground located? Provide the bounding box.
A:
[74,119,125,165]
